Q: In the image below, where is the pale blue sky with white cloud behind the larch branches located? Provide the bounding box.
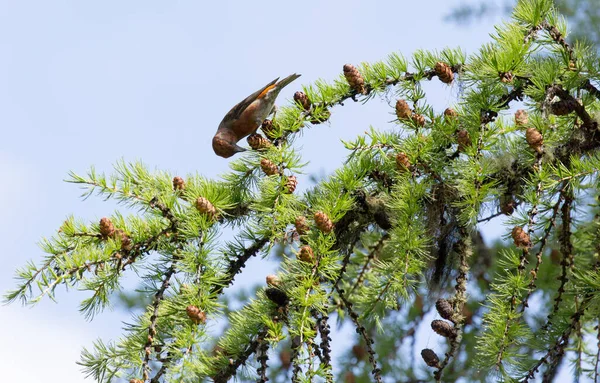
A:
[0,0,512,383]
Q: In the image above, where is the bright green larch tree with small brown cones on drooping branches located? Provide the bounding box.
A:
[6,0,600,383]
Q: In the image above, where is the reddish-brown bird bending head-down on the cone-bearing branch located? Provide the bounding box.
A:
[212,73,300,158]
